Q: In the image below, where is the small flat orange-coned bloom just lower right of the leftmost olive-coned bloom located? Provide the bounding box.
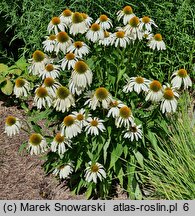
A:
[40,64,60,79]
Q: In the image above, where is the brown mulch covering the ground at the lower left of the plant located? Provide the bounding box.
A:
[0,100,127,200]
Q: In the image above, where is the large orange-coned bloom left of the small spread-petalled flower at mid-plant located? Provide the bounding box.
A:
[61,115,82,139]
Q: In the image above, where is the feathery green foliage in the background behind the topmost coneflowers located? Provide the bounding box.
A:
[0,0,195,79]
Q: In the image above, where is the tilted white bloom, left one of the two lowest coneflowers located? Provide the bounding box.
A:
[53,163,73,179]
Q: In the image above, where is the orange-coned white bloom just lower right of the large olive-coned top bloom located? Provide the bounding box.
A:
[86,23,104,43]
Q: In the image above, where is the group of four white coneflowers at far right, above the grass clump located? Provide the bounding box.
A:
[123,69,192,113]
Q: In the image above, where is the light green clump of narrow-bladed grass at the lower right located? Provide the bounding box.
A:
[141,94,195,200]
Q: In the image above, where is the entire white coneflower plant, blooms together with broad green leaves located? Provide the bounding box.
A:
[5,5,192,199]
